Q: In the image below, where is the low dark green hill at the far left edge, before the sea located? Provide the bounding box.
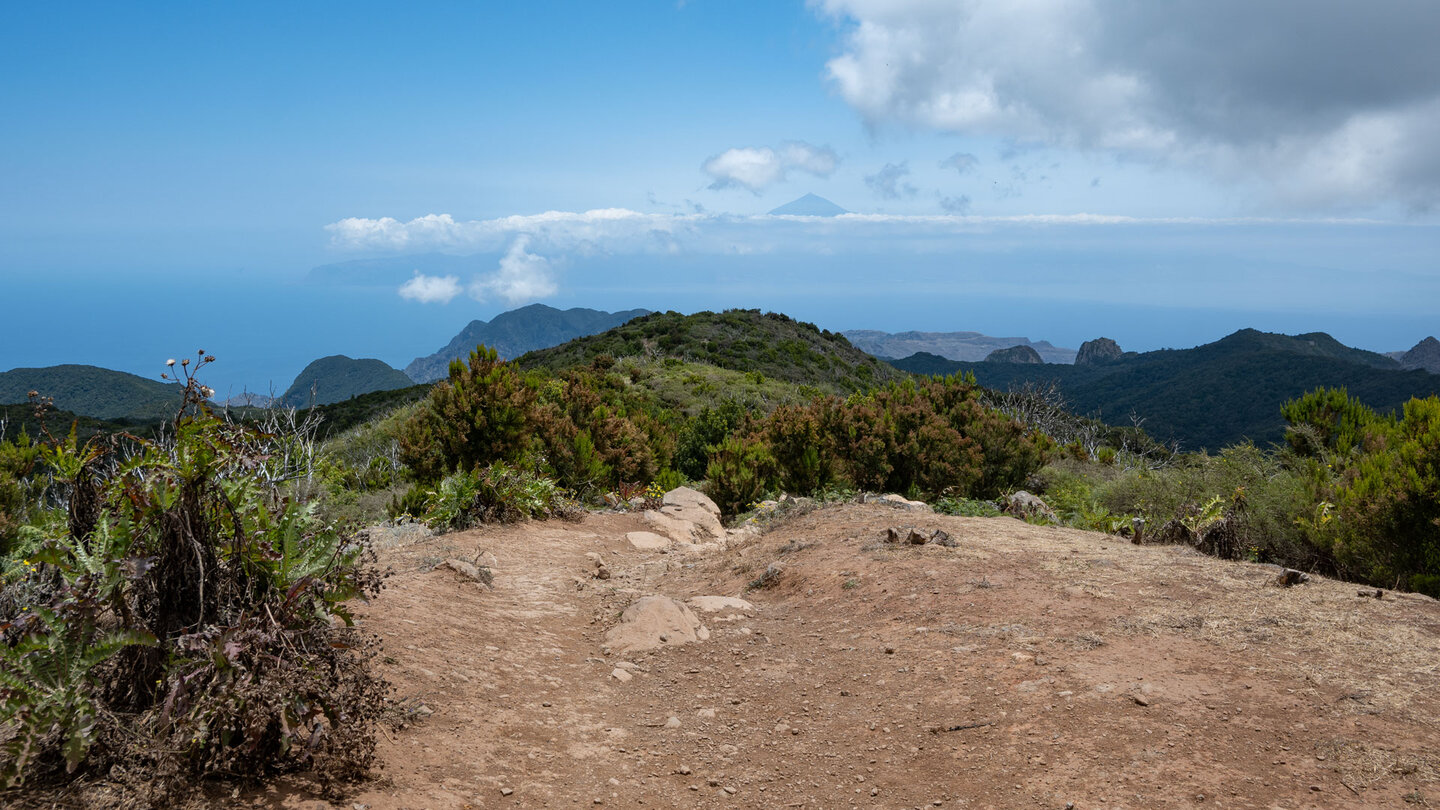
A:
[0,365,180,419]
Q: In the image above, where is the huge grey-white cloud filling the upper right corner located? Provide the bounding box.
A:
[815,0,1440,206]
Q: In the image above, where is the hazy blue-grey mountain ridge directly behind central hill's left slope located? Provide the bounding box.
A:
[405,304,649,382]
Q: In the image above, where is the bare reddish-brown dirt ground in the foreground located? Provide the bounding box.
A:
[262,504,1440,810]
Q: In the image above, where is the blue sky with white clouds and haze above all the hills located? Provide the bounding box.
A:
[0,0,1440,393]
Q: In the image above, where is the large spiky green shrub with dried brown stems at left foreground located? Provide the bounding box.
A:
[0,355,384,804]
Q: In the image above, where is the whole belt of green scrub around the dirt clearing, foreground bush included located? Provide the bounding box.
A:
[0,306,1440,801]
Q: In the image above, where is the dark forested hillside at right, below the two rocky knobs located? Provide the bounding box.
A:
[894,329,1440,450]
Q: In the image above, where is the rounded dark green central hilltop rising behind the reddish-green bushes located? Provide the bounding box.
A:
[517,310,906,393]
